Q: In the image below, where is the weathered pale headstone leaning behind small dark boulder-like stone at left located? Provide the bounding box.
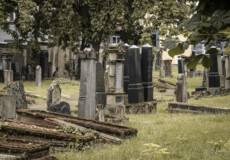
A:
[47,81,61,111]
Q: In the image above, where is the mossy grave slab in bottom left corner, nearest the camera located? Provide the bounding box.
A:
[0,138,50,159]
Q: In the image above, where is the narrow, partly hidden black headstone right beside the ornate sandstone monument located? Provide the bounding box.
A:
[124,44,129,94]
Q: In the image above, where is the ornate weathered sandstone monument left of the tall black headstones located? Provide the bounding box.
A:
[104,44,127,122]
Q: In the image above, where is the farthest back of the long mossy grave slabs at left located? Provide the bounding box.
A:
[17,109,138,138]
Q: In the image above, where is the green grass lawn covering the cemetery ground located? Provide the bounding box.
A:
[0,67,230,160]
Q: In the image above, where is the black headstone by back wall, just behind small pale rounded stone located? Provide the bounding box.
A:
[40,50,49,78]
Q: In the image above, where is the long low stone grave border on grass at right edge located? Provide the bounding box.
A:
[167,103,230,114]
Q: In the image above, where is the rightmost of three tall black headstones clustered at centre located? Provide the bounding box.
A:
[141,44,153,102]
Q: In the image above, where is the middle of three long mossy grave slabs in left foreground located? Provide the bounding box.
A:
[0,121,98,149]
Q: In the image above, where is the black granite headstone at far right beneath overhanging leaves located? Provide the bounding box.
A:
[208,54,220,88]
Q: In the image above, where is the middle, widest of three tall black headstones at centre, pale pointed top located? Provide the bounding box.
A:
[128,45,144,103]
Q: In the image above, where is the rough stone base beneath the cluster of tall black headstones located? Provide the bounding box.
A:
[126,101,157,114]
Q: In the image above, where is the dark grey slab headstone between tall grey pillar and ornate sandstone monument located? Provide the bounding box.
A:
[96,62,106,106]
